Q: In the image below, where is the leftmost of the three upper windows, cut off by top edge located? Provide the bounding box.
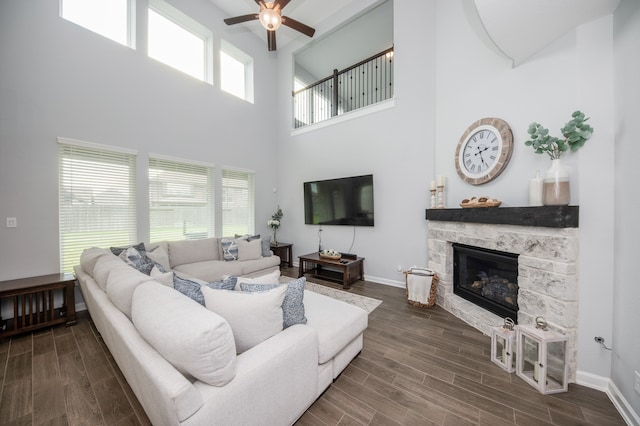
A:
[60,0,135,47]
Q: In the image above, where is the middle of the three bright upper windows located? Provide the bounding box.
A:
[148,0,213,84]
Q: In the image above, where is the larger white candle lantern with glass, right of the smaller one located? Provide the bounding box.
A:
[516,317,568,394]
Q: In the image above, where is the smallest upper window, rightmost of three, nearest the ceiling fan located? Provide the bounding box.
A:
[220,40,253,103]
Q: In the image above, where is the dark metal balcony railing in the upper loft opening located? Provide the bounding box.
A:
[293,47,393,129]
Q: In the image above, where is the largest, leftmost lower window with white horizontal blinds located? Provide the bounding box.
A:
[58,139,137,272]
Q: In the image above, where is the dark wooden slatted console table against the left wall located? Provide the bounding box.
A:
[0,274,76,339]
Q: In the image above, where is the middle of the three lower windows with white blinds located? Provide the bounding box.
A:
[149,157,214,242]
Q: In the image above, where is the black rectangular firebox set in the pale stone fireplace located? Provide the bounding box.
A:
[453,243,518,323]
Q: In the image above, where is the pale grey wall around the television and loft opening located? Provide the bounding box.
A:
[278,1,435,285]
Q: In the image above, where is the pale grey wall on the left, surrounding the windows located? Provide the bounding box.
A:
[0,0,277,280]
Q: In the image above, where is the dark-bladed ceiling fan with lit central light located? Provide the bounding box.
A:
[224,0,316,51]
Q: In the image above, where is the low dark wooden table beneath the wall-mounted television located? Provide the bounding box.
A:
[298,252,364,289]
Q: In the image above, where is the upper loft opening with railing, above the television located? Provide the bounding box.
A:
[293,0,394,128]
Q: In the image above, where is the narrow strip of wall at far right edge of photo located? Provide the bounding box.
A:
[602,0,640,422]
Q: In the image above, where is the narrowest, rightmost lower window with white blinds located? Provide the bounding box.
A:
[222,170,255,236]
